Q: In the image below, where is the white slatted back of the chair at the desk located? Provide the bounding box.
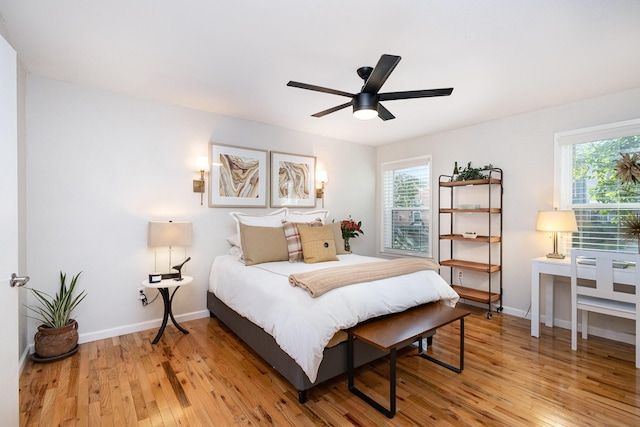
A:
[571,249,640,304]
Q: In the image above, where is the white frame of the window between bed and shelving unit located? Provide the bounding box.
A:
[379,154,433,258]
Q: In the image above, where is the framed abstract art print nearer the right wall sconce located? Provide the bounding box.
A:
[271,151,316,208]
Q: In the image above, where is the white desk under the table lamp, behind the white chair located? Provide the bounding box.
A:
[531,255,634,337]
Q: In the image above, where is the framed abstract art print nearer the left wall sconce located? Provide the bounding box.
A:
[209,142,268,208]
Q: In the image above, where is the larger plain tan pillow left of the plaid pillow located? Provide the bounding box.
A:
[240,223,289,265]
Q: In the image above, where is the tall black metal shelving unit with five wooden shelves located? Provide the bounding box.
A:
[438,168,503,319]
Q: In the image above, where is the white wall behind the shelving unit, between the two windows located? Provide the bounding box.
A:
[376,89,640,334]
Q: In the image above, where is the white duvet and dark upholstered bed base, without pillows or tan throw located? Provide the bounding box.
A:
[207,254,458,402]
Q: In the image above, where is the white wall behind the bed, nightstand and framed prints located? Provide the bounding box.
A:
[26,76,376,348]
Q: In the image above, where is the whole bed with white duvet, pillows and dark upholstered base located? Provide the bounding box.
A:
[207,210,459,403]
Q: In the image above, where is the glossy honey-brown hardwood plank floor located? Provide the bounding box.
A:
[20,308,640,427]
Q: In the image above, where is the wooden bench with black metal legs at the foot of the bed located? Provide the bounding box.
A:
[347,303,471,418]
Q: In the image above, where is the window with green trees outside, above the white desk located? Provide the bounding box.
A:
[555,120,640,252]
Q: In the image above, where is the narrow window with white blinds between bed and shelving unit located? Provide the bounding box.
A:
[381,156,431,257]
